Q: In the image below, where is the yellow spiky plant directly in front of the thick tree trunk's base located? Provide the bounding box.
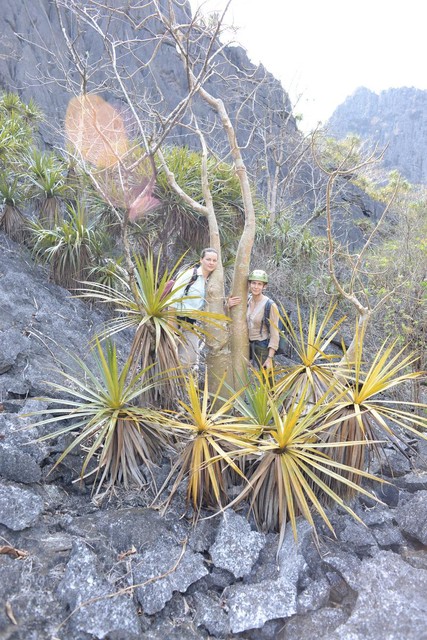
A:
[156,374,258,520]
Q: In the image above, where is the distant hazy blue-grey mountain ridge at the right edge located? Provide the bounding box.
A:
[327,87,427,184]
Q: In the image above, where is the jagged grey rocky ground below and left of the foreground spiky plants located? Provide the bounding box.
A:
[0,235,427,640]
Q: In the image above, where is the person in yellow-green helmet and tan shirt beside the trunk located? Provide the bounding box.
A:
[230,269,280,369]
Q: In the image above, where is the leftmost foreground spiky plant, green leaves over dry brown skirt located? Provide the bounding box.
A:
[25,340,169,497]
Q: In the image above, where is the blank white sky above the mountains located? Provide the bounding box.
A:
[190,0,427,131]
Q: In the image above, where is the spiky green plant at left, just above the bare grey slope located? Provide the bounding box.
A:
[30,202,105,289]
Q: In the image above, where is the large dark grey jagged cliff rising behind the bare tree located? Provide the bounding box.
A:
[0,0,390,248]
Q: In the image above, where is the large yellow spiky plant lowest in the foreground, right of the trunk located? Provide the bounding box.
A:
[229,386,386,546]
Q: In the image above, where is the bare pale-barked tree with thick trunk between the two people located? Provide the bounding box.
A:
[43,0,290,384]
